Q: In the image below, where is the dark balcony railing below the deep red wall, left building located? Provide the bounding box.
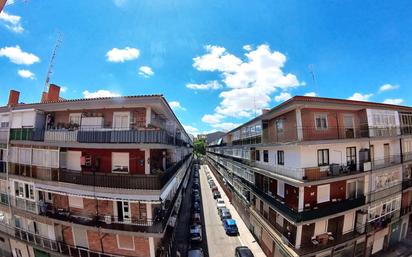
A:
[58,155,191,190]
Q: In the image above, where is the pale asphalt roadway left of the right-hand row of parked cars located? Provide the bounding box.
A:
[199,165,242,257]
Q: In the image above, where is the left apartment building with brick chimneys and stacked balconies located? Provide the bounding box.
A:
[0,85,192,257]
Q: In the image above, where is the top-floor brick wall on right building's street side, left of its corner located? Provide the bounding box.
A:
[267,110,297,143]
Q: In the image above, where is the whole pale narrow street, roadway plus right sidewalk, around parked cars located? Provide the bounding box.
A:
[199,165,265,257]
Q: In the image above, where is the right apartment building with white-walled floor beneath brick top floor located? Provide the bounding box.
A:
[207,96,412,257]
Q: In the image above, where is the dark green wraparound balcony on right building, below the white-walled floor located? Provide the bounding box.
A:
[242,180,365,222]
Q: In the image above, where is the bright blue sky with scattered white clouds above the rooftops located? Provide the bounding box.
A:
[0,0,412,134]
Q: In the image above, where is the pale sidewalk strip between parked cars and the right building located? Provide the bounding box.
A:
[201,165,266,257]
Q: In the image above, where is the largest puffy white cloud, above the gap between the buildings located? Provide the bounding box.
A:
[193,44,303,123]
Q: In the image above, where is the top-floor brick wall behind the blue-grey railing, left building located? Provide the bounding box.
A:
[54,108,146,127]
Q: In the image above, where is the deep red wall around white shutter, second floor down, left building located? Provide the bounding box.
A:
[68,148,145,174]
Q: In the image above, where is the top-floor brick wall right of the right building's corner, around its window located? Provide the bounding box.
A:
[301,108,363,140]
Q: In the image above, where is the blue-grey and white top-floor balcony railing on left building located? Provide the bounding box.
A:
[10,127,187,146]
